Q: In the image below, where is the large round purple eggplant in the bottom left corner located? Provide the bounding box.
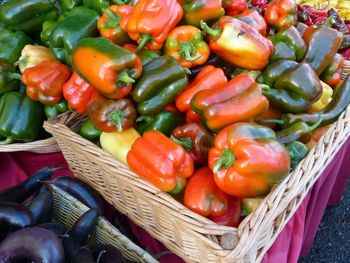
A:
[0,227,64,263]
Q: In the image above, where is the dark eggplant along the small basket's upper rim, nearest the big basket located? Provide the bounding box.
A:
[47,176,104,215]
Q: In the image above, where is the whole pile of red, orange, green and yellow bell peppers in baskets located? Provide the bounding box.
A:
[0,0,350,227]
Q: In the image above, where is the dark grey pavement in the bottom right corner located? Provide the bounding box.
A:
[298,180,350,263]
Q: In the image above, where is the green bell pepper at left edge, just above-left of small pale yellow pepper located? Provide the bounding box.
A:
[0,29,31,64]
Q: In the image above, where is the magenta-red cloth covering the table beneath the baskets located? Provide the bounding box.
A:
[0,139,350,263]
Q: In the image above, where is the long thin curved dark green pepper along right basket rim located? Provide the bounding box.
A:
[282,76,350,127]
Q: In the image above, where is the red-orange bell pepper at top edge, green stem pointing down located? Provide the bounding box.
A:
[126,0,183,50]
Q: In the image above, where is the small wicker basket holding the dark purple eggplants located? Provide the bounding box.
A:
[50,185,158,263]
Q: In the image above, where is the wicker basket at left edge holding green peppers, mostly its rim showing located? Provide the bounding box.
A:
[0,112,84,153]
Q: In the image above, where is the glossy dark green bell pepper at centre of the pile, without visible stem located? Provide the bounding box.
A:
[132,55,188,115]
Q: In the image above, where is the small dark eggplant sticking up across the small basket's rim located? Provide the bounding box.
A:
[68,209,100,246]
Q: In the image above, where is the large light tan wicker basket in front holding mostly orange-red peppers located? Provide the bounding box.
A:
[44,68,350,263]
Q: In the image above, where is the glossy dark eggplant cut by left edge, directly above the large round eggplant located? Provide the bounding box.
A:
[0,202,33,238]
